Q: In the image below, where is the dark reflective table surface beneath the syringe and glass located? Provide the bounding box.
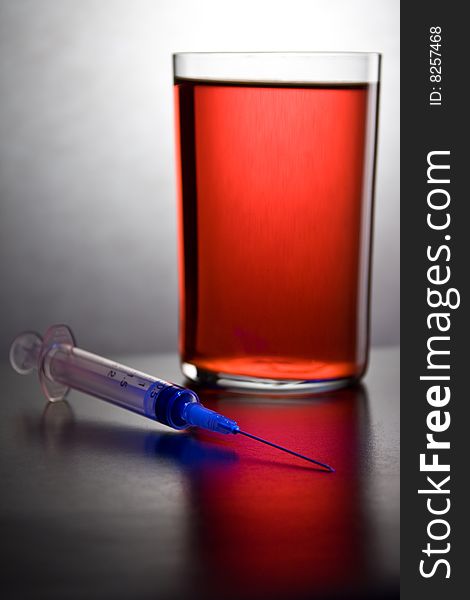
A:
[0,348,399,600]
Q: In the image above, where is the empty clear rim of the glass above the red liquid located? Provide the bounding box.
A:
[172,51,382,84]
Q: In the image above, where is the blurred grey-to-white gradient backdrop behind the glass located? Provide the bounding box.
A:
[0,0,399,353]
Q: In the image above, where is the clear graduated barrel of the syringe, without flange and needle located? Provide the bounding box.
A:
[41,344,199,429]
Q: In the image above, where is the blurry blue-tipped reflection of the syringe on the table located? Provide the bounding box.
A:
[18,400,238,469]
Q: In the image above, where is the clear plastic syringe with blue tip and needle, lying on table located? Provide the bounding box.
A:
[10,325,334,472]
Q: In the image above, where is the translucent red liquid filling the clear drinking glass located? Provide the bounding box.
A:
[175,81,377,380]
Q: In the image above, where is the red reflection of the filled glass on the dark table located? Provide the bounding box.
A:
[185,386,384,598]
